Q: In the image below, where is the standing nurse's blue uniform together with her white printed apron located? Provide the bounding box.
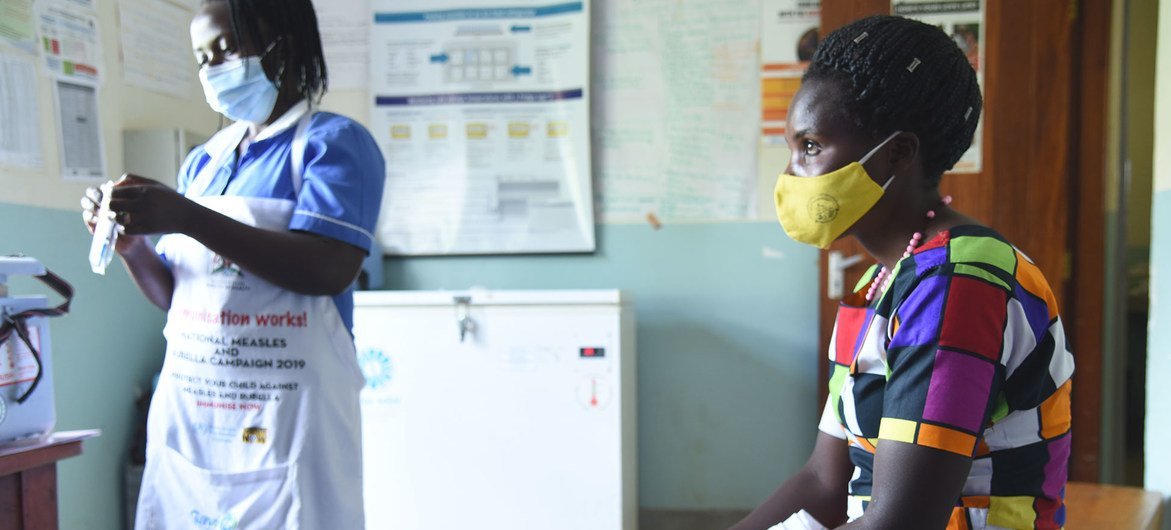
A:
[135,101,384,530]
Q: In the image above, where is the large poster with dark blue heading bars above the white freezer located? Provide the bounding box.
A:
[370,0,595,255]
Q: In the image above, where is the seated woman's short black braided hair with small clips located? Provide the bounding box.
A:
[803,16,984,186]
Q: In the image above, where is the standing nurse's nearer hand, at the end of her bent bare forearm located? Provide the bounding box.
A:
[110,174,198,235]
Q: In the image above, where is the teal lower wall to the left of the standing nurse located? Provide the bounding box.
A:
[0,204,164,530]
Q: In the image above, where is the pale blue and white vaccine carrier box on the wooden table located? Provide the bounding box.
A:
[0,257,56,445]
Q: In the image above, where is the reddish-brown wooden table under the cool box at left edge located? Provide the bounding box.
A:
[0,431,97,530]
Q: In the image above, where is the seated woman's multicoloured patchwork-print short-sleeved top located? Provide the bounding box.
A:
[820,226,1074,530]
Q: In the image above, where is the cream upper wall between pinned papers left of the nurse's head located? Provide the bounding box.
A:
[0,0,219,209]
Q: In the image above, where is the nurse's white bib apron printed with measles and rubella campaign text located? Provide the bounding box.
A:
[136,116,364,530]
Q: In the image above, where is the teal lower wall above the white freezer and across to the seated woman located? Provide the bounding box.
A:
[384,222,822,509]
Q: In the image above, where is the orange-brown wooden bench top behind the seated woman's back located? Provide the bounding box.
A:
[1066,482,1163,530]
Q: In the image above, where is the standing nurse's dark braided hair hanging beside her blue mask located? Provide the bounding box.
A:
[204,0,329,101]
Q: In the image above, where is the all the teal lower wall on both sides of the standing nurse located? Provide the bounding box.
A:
[0,204,821,521]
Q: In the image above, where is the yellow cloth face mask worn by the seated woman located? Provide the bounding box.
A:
[773,131,900,248]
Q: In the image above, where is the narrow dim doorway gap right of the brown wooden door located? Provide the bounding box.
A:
[1102,0,1159,487]
